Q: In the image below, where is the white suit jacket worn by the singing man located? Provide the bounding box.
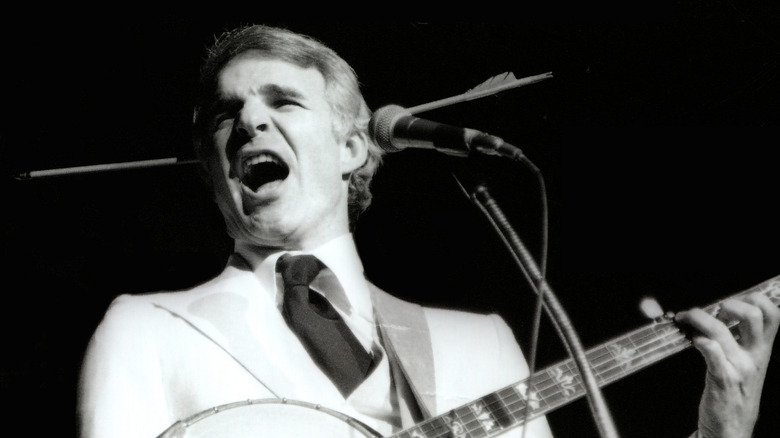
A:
[79,258,551,438]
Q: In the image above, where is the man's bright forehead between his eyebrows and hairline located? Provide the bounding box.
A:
[217,52,325,98]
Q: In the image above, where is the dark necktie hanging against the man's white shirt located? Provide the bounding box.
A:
[278,255,372,398]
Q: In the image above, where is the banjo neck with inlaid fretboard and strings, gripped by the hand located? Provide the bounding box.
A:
[389,276,780,438]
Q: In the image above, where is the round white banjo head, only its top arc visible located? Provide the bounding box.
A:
[157,399,381,438]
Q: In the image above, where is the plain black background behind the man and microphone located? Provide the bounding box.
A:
[0,1,780,437]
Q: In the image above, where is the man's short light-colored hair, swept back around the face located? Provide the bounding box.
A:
[193,25,384,227]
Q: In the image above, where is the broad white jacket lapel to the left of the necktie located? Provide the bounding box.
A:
[154,257,343,403]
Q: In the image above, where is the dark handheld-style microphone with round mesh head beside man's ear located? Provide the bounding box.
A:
[368,105,523,159]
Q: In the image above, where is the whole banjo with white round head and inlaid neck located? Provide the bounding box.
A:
[157,275,780,438]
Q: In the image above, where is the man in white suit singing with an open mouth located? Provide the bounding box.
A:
[79,26,780,438]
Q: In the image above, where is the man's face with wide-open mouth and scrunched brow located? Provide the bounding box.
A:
[209,53,365,249]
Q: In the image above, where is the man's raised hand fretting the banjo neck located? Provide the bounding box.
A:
[676,293,780,438]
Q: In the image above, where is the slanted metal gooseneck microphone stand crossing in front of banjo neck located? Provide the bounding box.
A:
[453,154,619,438]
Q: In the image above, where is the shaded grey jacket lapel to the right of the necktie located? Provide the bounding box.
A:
[369,283,436,417]
